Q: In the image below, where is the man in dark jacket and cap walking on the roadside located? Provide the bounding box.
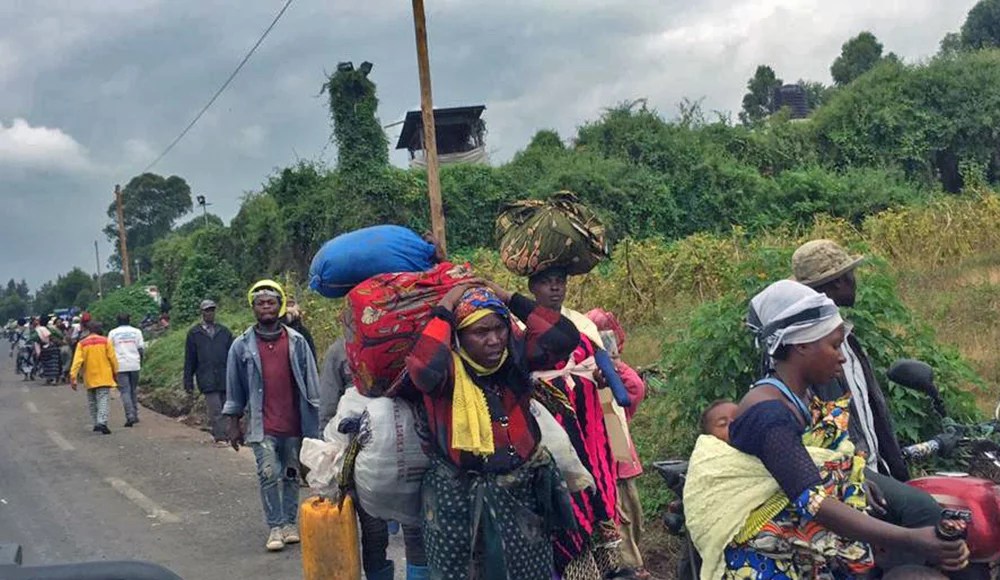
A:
[184,300,233,443]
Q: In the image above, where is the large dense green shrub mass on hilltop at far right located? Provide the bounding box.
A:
[815,50,1000,192]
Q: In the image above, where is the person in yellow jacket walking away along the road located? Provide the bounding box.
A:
[69,321,118,435]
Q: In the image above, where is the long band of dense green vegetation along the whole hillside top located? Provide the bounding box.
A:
[76,34,1000,328]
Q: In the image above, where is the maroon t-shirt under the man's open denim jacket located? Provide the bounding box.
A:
[257,330,302,437]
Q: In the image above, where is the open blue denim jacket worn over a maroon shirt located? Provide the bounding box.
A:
[222,326,319,443]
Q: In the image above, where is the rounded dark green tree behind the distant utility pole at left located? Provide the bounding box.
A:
[104,173,192,271]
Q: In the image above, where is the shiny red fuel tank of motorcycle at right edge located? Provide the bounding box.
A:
[908,474,1000,562]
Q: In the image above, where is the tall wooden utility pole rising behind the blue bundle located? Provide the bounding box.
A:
[413,0,448,253]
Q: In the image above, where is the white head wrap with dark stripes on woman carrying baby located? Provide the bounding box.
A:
[747,280,844,355]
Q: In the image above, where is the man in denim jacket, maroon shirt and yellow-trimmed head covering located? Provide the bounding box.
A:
[223,280,319,551]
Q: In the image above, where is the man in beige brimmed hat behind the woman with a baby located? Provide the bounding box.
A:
[792,240,941,560]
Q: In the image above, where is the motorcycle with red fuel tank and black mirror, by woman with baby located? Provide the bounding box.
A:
[653,359,1000,580]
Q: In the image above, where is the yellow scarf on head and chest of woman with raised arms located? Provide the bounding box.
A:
[451,308,508,456]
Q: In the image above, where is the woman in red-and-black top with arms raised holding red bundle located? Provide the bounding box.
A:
[406,283,579,580]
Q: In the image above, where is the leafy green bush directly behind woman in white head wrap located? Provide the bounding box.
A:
[663,245,980,444]
